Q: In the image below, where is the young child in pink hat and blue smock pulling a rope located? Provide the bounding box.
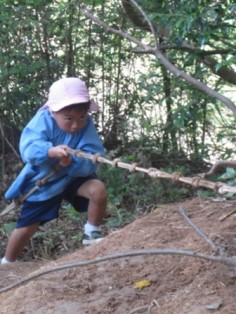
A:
[1,77,107,264]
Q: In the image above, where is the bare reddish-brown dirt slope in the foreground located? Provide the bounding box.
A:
[0,198,236,314]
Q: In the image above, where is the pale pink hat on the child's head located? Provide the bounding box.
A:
[44,77,98,111]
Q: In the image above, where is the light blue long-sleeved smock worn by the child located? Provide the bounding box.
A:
[5,109,104,202]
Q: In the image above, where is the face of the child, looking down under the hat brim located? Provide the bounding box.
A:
[53,108,88,134]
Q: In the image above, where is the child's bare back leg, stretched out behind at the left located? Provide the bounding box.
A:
[5,223,39,262]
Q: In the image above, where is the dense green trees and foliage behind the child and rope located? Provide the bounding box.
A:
[0,0,236,224]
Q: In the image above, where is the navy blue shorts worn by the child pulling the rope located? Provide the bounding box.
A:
[16,174,97,228]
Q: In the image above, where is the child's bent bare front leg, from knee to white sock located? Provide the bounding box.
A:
[77,179,107,226]
